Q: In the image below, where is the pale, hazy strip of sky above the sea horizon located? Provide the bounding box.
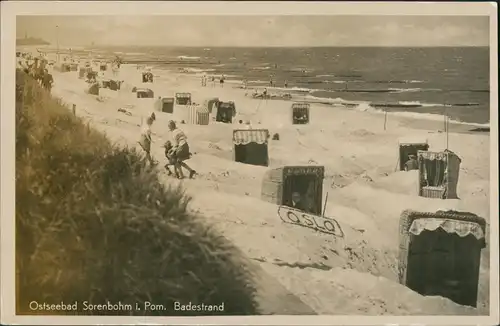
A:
[16,15,489,47]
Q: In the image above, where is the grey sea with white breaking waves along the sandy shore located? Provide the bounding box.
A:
[49,46,490,124]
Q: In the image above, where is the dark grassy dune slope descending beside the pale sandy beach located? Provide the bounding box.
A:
[16,71,257,315]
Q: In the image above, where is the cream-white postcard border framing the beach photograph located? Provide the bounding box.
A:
[0,1,499,325]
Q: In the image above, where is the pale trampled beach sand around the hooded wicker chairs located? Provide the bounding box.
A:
[42,57,490,315]
